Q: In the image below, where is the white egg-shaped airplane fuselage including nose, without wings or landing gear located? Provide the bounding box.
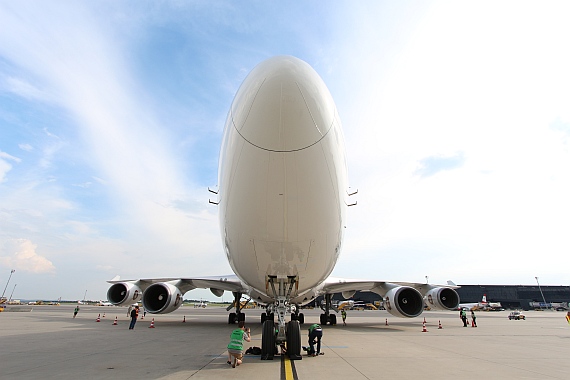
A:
[219,56,348,295]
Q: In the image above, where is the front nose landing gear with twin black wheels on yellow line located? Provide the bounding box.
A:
[261,276,305,360]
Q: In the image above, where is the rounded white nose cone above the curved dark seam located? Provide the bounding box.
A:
[231,56,335,152]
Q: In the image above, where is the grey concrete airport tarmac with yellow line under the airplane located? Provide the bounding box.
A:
[0,305,570,380]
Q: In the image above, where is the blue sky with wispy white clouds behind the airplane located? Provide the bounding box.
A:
[0,1,570,299]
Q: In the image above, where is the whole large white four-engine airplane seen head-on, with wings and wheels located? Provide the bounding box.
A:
[107,56,459,360]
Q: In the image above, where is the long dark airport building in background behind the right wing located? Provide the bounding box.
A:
[316,285,570,310]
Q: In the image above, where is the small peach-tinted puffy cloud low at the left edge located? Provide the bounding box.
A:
[0,239,55,273]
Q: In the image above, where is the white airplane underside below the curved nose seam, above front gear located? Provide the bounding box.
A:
[223,134,343,292]
